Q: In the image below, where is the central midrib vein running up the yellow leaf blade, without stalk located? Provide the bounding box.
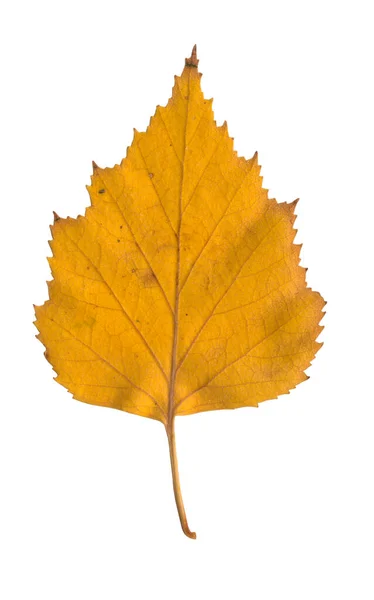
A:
[167,71,191,425]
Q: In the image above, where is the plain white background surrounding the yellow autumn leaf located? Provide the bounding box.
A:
[0,0,374,600]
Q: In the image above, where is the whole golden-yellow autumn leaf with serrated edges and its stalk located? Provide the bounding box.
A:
[36,47,325,537]
